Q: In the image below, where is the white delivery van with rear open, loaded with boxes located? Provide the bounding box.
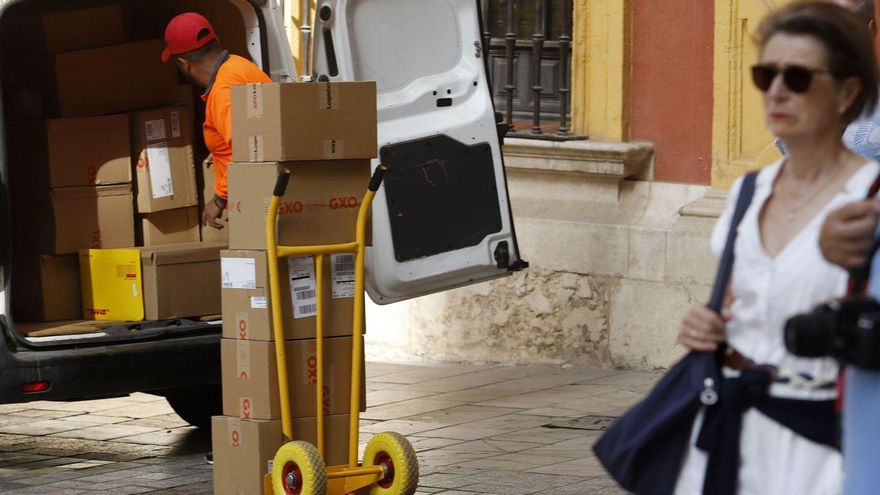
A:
[0,0,527,426]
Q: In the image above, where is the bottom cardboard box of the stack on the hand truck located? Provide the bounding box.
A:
[211,414,349,495]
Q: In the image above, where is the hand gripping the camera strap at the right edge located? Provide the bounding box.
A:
[819,199,880,269]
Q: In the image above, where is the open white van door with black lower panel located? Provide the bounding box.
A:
[312,0,528,304]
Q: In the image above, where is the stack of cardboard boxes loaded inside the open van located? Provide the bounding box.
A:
[2,4,223,328]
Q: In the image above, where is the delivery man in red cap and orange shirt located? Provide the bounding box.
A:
[162,12,272,229]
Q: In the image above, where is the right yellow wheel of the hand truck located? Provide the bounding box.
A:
[364,432,419,495]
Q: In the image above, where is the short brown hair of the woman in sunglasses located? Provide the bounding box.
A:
[758,1,878,124]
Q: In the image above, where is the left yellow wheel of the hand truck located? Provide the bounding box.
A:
[272,441,327,495]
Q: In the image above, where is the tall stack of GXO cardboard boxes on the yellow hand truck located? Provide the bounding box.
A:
[212,82,377,494]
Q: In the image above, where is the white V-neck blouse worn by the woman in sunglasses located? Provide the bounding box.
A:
[711,160,880,399]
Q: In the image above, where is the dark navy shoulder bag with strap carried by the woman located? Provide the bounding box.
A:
[593,172,757,495]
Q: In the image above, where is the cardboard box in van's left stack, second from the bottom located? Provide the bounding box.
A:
[13,184,134,254]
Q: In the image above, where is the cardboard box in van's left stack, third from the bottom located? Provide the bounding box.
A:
[9,115,131,187]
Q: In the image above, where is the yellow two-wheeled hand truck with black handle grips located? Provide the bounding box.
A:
[263,165,419,495]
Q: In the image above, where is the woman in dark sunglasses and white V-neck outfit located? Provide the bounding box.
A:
[676,2,880,494]
